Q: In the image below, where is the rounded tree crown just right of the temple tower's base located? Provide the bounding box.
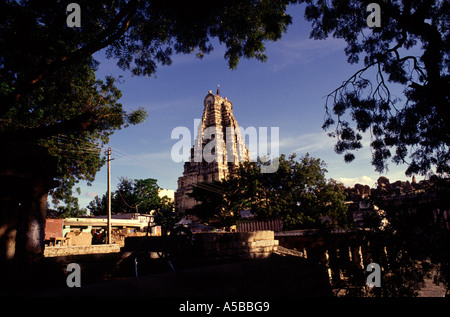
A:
[244,153,347,229]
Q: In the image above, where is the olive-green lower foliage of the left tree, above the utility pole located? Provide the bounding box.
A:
[37,74,146,209]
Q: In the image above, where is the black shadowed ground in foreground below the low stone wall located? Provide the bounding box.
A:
[33,254,332,297]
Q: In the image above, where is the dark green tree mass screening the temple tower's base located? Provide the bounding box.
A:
[188,153,347,229]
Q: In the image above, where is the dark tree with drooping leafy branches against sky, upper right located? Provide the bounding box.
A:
[301,0,450,175]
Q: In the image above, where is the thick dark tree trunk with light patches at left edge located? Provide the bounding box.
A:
[0,143,58,293]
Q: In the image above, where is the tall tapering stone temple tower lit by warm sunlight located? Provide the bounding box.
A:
[175,89,249,212]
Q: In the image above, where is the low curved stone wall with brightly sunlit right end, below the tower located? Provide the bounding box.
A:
[194,230,278,259]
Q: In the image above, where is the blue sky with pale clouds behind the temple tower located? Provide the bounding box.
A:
[73,6,418,207]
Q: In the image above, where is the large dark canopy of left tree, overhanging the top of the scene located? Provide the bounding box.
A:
[0,0,298,209]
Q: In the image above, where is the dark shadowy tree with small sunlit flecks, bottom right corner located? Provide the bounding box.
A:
[360,176,450,297]
